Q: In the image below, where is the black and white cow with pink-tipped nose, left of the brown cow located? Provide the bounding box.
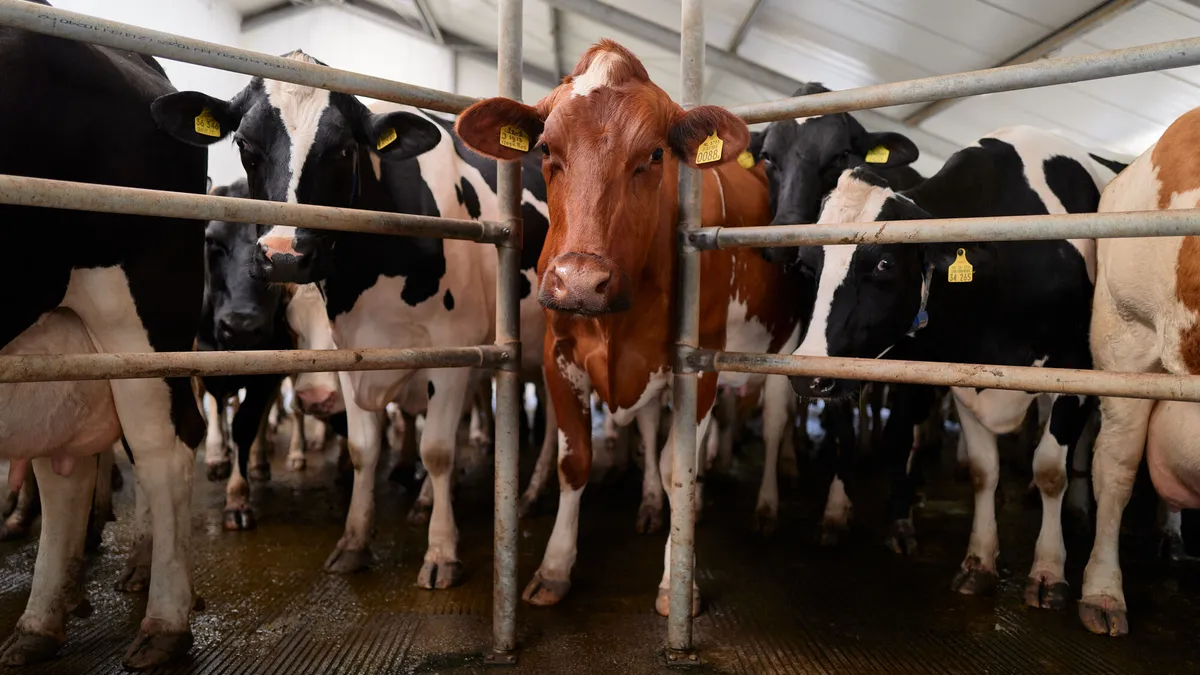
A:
[155,52,557,589]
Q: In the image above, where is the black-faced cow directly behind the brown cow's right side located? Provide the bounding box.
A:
[744,83,923,535]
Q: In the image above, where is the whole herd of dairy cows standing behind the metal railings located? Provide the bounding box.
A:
[0,5,1200,668]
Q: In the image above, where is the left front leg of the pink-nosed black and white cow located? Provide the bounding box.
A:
[325,372,383,574]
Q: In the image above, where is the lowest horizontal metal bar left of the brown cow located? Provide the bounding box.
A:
[0,345,509,383]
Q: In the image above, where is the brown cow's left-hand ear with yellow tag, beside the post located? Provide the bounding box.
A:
[454,97,545,160]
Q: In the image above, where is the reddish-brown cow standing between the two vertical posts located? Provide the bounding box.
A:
[457,41,798,615]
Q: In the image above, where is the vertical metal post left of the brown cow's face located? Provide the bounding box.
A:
[488,0,532,663]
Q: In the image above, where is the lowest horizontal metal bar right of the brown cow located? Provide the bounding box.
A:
[694,352,1200,401]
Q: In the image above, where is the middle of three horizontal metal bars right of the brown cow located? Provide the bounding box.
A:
[689,209,1200,250]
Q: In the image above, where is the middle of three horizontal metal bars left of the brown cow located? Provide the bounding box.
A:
[0,174,510,244]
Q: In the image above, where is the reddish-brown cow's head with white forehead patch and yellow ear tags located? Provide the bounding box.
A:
[456,41,750,316]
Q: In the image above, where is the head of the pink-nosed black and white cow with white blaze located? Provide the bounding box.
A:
[151,50,442,282]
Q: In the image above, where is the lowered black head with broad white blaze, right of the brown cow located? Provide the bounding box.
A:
[792,168,990,398]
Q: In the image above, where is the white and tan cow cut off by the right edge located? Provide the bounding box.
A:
[1079,109,1200,635]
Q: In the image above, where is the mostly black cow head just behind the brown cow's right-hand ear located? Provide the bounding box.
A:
[750,83,919,263]
